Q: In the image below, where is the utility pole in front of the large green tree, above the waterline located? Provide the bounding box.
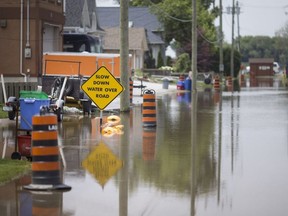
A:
[191,0,197,92]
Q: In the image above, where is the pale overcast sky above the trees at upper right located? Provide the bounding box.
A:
[218,0,288,41]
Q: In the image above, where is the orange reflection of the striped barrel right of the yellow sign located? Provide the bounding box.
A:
[142,128,156,160]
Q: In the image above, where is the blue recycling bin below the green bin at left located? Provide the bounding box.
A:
[19,98,50,130]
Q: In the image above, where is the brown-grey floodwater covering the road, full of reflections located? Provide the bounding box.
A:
[0,77,288,216]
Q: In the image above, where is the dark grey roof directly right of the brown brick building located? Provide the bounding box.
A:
[65,0,103,30]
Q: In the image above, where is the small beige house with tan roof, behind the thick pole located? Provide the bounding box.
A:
[103,27,149,69]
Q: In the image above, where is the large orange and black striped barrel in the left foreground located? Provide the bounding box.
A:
[24,114,71,190]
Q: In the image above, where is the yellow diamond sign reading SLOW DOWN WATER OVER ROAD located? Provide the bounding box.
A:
[81,66,124,110]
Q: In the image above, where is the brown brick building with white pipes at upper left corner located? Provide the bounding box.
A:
[0,0,65,82]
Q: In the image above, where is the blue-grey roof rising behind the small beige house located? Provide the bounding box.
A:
[96,7,164,44]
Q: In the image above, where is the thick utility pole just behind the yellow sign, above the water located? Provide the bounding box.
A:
[120,0,130,112]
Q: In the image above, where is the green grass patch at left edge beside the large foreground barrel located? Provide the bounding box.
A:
[0,159,31,185]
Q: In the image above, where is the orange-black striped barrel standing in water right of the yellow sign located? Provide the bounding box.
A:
[142,89,157,127]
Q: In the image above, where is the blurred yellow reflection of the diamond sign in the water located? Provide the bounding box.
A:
[82,142,123,187]
